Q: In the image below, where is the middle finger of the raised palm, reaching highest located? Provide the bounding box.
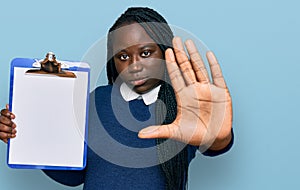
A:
[173,37,197,85]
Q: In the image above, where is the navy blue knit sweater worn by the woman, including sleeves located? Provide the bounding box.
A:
[44,85,233,190]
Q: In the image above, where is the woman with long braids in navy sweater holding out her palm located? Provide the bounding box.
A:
[0,7,233,190]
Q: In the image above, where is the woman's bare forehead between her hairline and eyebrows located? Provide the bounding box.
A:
[112,23,155,51]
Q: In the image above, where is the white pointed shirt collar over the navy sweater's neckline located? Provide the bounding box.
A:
[120,82,161,105]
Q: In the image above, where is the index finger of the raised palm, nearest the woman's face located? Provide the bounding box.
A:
[165,49,185,92]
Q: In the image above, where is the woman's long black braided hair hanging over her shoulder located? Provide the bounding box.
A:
[106,7,188,190]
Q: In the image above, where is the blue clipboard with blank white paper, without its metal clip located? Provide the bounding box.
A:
[7,58,90,170]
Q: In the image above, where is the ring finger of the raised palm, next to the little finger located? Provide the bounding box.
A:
[185,40,209,82]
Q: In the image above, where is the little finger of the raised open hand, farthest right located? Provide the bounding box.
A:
[206,51,226,88]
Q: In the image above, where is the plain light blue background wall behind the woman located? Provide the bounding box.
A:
[0,0,300,190]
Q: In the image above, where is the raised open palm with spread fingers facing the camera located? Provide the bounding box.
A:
[139,37,232,150]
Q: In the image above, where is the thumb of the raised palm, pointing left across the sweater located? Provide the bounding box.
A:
[138,125,172,139]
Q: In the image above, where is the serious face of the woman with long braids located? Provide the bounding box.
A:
[113,23,165,94]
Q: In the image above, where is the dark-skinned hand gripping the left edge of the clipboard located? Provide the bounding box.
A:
[0,104,17,143]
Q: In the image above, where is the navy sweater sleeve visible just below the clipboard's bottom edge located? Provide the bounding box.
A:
[43,169,86,187]
